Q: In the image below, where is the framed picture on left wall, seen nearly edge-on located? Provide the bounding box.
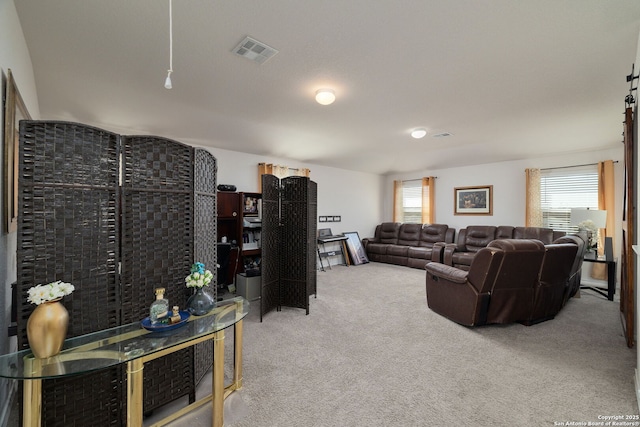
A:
[2,70,31,233]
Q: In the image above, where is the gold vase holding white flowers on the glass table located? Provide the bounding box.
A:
[27,280,75,359]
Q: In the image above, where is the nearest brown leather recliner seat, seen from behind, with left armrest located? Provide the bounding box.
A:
[425,239,545,326]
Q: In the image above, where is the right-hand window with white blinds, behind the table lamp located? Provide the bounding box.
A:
[540,165,598,232]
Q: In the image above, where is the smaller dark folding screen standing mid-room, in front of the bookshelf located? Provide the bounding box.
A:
[261,175,317,315]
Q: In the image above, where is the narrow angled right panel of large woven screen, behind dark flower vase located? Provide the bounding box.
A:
[193,148,218,384]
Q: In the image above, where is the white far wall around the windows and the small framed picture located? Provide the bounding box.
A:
[383,148,624,254]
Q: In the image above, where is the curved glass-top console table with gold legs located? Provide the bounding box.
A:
[0,297,249,427]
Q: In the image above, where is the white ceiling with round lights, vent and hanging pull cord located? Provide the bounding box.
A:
[15,0,640,174]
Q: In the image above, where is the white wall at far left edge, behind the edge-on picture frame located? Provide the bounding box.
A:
[0,0,40,425]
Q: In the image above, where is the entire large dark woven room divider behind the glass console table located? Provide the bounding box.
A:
[17,121,217,427]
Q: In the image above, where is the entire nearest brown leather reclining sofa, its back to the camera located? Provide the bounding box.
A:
[425,239,578,326]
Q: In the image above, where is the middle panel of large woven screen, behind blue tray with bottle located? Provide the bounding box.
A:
[120,136,195,412]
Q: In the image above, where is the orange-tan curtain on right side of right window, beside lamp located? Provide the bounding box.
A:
[591,160,616,280]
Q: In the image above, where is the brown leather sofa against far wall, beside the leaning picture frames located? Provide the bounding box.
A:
[362,222,455,269]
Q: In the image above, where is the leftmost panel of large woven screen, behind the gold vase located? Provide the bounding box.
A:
[17,121,126,427]
